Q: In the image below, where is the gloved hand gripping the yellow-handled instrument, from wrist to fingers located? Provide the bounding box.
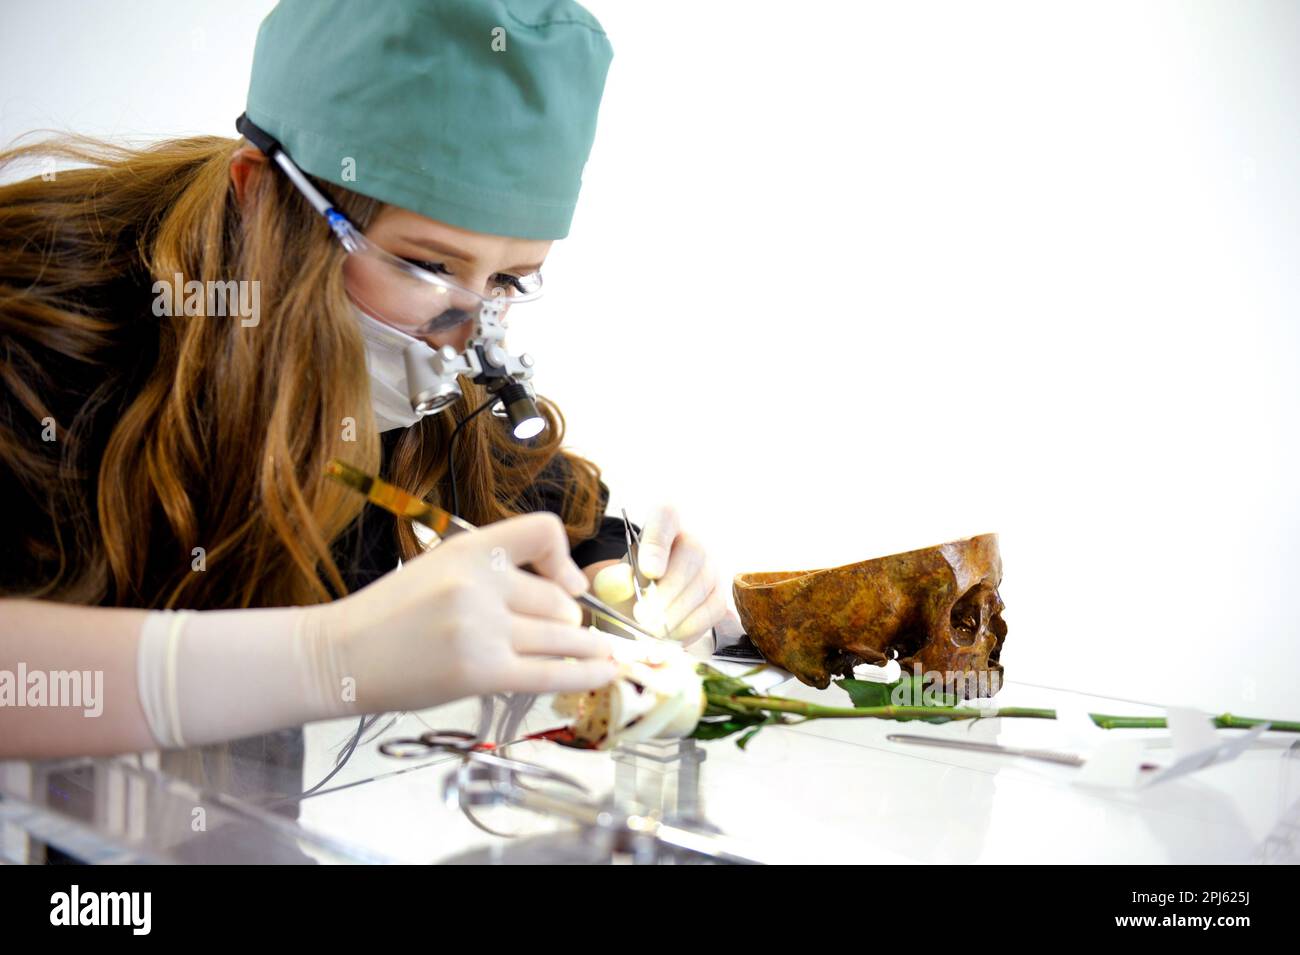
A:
[327,512,615,712]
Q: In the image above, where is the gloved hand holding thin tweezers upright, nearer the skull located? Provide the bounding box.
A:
[592,505,727,644]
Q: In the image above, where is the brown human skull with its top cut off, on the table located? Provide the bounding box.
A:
[732,534,1006,699]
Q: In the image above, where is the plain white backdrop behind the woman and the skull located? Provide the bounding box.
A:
[0,0,1300,719]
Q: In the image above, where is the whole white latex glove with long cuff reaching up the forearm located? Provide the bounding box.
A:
[139,512,616,747]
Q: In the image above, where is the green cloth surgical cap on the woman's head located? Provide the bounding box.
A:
[247,0,614,239]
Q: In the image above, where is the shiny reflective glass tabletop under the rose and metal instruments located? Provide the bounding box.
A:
[0,682,1300,864]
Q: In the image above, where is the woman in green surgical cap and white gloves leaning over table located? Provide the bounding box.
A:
[0,0,724,758]
